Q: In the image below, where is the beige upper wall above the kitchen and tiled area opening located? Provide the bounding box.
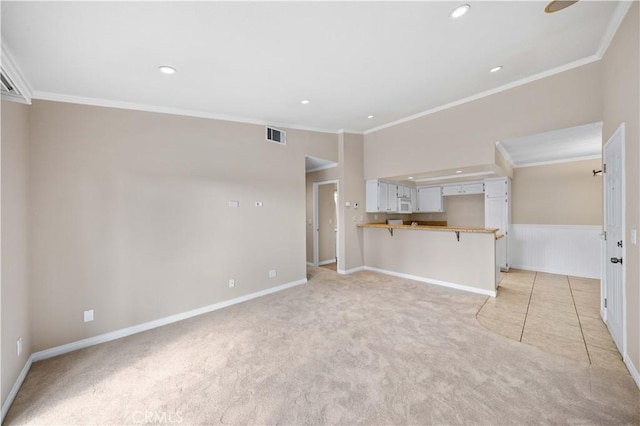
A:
[364,63,602,179]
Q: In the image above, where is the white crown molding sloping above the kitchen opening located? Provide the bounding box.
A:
[363,55,601,135]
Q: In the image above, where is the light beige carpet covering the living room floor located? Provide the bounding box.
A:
[6,268,640,425]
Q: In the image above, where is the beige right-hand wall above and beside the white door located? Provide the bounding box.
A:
[602,2,640,380]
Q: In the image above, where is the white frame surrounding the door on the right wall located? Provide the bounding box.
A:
[600,123,627,358]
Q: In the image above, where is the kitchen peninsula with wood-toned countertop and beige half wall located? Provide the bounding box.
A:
[358,223,502,297]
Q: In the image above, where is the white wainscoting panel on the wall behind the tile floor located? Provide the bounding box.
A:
[509,224,602,279]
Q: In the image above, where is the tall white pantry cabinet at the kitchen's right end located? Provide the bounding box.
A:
[484,177,511,271]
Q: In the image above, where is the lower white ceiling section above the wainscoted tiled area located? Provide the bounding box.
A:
[499,122,602,167]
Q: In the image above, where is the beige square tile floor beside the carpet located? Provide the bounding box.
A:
[477,270,629,374]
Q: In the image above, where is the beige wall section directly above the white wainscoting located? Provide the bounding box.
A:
[511,159,602,225]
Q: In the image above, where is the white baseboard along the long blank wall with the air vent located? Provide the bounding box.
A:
[31,278,307,362]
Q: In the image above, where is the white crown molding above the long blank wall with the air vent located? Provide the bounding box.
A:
[32,91,337,134]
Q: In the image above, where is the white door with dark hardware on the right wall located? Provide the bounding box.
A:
[604,123,627,353]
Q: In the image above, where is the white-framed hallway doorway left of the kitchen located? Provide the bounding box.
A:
[313,180,339,266]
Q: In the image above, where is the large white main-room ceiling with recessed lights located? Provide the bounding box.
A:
[1,0,628,132]
